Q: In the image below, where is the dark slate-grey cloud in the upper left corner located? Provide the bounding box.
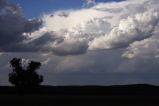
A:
[0,0,41,52]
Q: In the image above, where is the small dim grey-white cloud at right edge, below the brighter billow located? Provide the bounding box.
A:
[123,17,159,59]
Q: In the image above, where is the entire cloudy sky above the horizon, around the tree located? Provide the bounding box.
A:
[0,0,159,85]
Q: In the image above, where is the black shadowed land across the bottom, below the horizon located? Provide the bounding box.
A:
[0,85,159,106]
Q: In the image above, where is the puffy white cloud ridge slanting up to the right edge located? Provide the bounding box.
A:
[89,10,159,50]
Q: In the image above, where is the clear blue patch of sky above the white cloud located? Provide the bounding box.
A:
[10,0,122,18]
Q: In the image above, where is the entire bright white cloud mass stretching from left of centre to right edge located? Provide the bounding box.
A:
[23,0,159,55]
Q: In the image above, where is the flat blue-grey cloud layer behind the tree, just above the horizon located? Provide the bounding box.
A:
[0,49,159,85]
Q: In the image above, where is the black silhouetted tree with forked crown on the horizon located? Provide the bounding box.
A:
[9,58,43,87]
